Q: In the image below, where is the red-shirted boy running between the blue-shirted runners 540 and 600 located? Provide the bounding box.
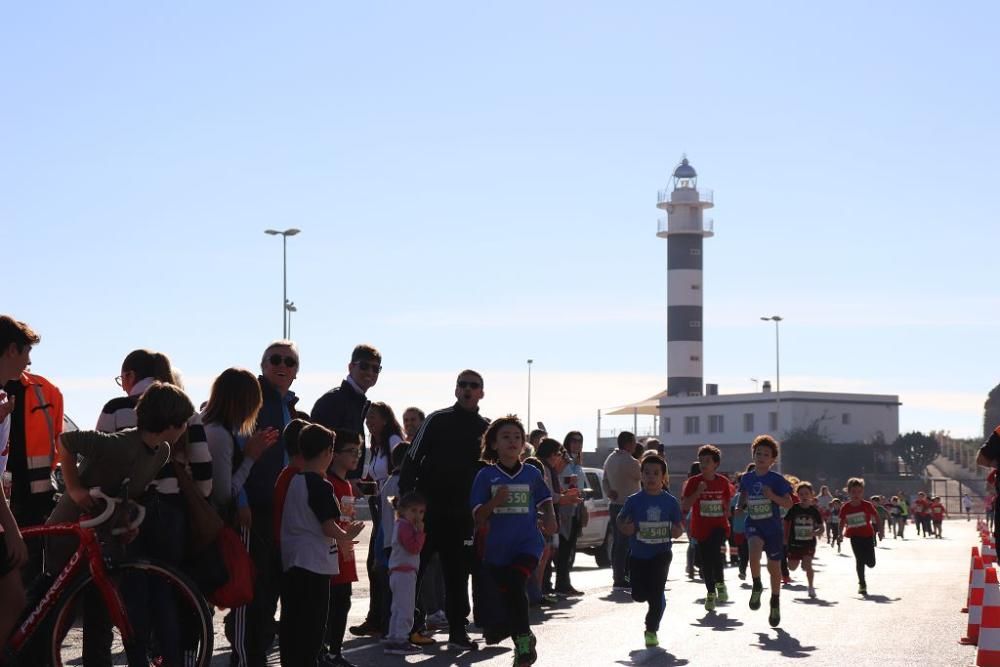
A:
[681,445,733,611]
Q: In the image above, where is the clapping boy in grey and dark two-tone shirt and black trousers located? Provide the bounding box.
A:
[278,424,364,667]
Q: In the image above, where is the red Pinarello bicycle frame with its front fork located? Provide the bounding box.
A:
[6,523,133,655]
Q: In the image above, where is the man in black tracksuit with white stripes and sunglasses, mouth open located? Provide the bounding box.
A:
[399,370,489,651]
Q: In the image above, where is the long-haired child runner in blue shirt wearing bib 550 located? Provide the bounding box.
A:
[469,415,557,667]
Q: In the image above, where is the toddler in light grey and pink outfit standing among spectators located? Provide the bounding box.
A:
[385,491,427,655]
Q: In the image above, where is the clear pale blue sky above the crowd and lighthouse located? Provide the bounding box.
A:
[0,2,1000,444]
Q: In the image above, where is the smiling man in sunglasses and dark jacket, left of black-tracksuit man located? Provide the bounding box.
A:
[312,345,382,479]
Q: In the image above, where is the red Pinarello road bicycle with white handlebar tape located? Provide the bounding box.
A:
[0,489,214,667]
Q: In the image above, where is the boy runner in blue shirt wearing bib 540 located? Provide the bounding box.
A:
[616,454,684,648]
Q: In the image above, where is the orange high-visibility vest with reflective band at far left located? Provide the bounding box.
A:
[16,372,63,493]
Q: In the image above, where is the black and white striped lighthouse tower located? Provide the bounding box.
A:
[656,157,714,396]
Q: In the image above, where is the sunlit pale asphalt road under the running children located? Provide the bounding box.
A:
[199,520,976,667]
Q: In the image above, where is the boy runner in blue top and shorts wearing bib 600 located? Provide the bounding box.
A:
[740,435,792,628]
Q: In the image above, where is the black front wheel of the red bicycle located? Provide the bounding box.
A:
[51,559,214,667]
